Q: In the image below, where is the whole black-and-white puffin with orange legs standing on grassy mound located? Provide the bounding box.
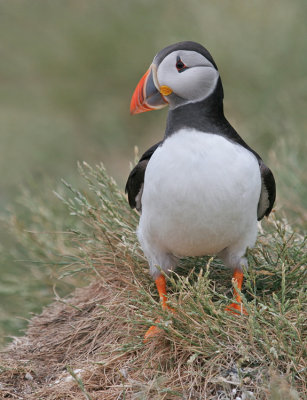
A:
[125,41,276,341]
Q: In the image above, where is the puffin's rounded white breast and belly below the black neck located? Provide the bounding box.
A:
[138,129,261,256]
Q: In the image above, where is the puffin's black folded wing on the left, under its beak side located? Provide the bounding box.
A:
[125,140,163,212]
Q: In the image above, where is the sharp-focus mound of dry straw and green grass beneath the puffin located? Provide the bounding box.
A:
[0,165,307,400]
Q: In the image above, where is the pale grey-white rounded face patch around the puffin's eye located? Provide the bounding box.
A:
[157,50,219,108]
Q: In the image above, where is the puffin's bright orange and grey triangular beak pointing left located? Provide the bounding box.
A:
[130,64,171,115]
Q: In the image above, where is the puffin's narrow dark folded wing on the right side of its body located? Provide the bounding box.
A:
[257,158,276,221]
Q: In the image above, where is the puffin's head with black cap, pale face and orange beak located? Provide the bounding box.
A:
[130,42,219,114]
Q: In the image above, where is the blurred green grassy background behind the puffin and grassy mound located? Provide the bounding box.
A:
[0,0,307,341]
